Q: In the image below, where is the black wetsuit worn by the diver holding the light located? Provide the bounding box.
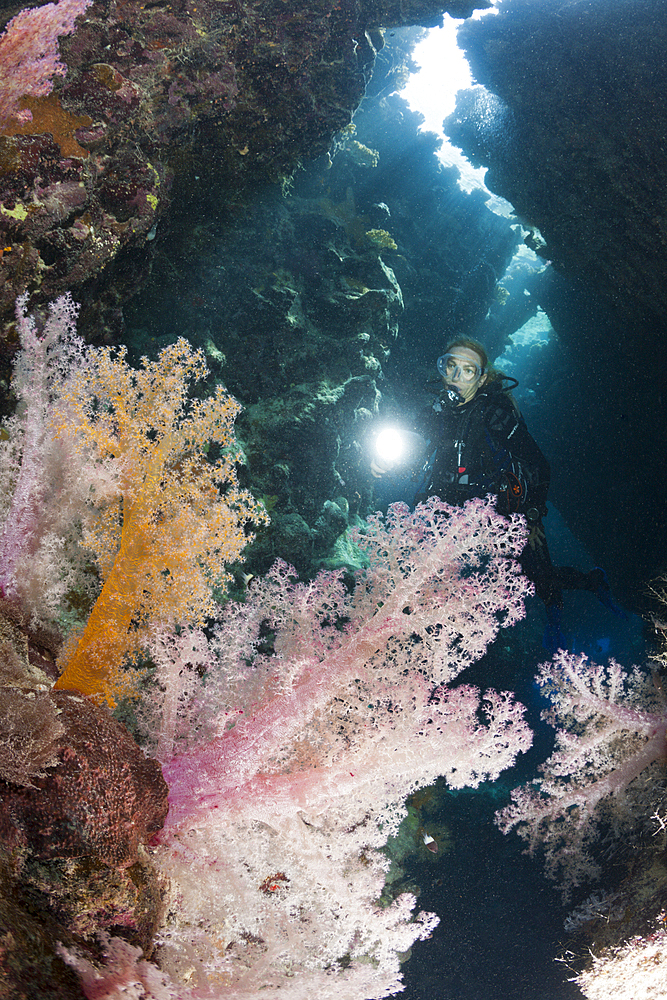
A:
[416,378,599,607]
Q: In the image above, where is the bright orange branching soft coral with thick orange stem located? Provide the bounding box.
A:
[56,339,266,705]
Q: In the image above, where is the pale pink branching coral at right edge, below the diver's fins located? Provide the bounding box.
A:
[497,650,667,898]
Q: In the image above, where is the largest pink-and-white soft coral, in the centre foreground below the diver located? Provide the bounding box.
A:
[132,498,531,1000]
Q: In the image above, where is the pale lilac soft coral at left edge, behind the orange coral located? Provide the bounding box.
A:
[0,294,109,620]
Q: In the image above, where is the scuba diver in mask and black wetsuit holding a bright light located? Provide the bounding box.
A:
[371,337,624,652]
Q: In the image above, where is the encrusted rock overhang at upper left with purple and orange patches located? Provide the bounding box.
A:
[0,0,487,339]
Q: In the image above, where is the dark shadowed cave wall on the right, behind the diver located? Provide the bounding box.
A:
[445,0,667,600]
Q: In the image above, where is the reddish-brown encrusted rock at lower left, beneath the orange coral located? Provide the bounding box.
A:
[0,601,167,1000]
